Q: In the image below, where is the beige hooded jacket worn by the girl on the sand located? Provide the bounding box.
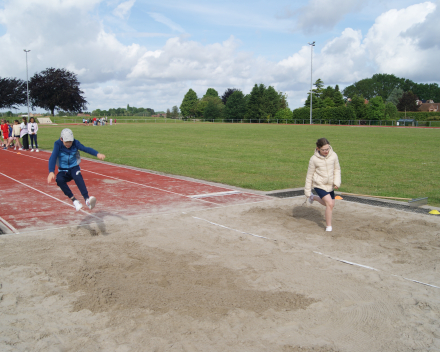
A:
[304,146,341,197]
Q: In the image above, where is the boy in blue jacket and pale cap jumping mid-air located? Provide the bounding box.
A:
[47,128,105,211]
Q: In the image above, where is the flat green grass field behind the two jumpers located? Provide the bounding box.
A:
[38,123,440,206]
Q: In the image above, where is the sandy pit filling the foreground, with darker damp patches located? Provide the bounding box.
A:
[0,197,440,352]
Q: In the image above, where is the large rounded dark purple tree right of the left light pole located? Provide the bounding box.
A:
[29,67,87,116]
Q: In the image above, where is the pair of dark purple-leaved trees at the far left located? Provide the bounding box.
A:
[0,67,87,116]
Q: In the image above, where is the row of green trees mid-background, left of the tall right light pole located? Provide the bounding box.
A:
[180,84,292,121]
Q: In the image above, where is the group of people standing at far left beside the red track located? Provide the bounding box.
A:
[0,117,39,152]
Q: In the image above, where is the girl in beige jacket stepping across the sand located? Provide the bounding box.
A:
[304,138,341,231]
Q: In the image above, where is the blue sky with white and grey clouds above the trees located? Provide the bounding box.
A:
[0,0,440,111]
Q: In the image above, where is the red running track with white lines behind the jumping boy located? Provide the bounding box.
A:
[0,150,269,233]
